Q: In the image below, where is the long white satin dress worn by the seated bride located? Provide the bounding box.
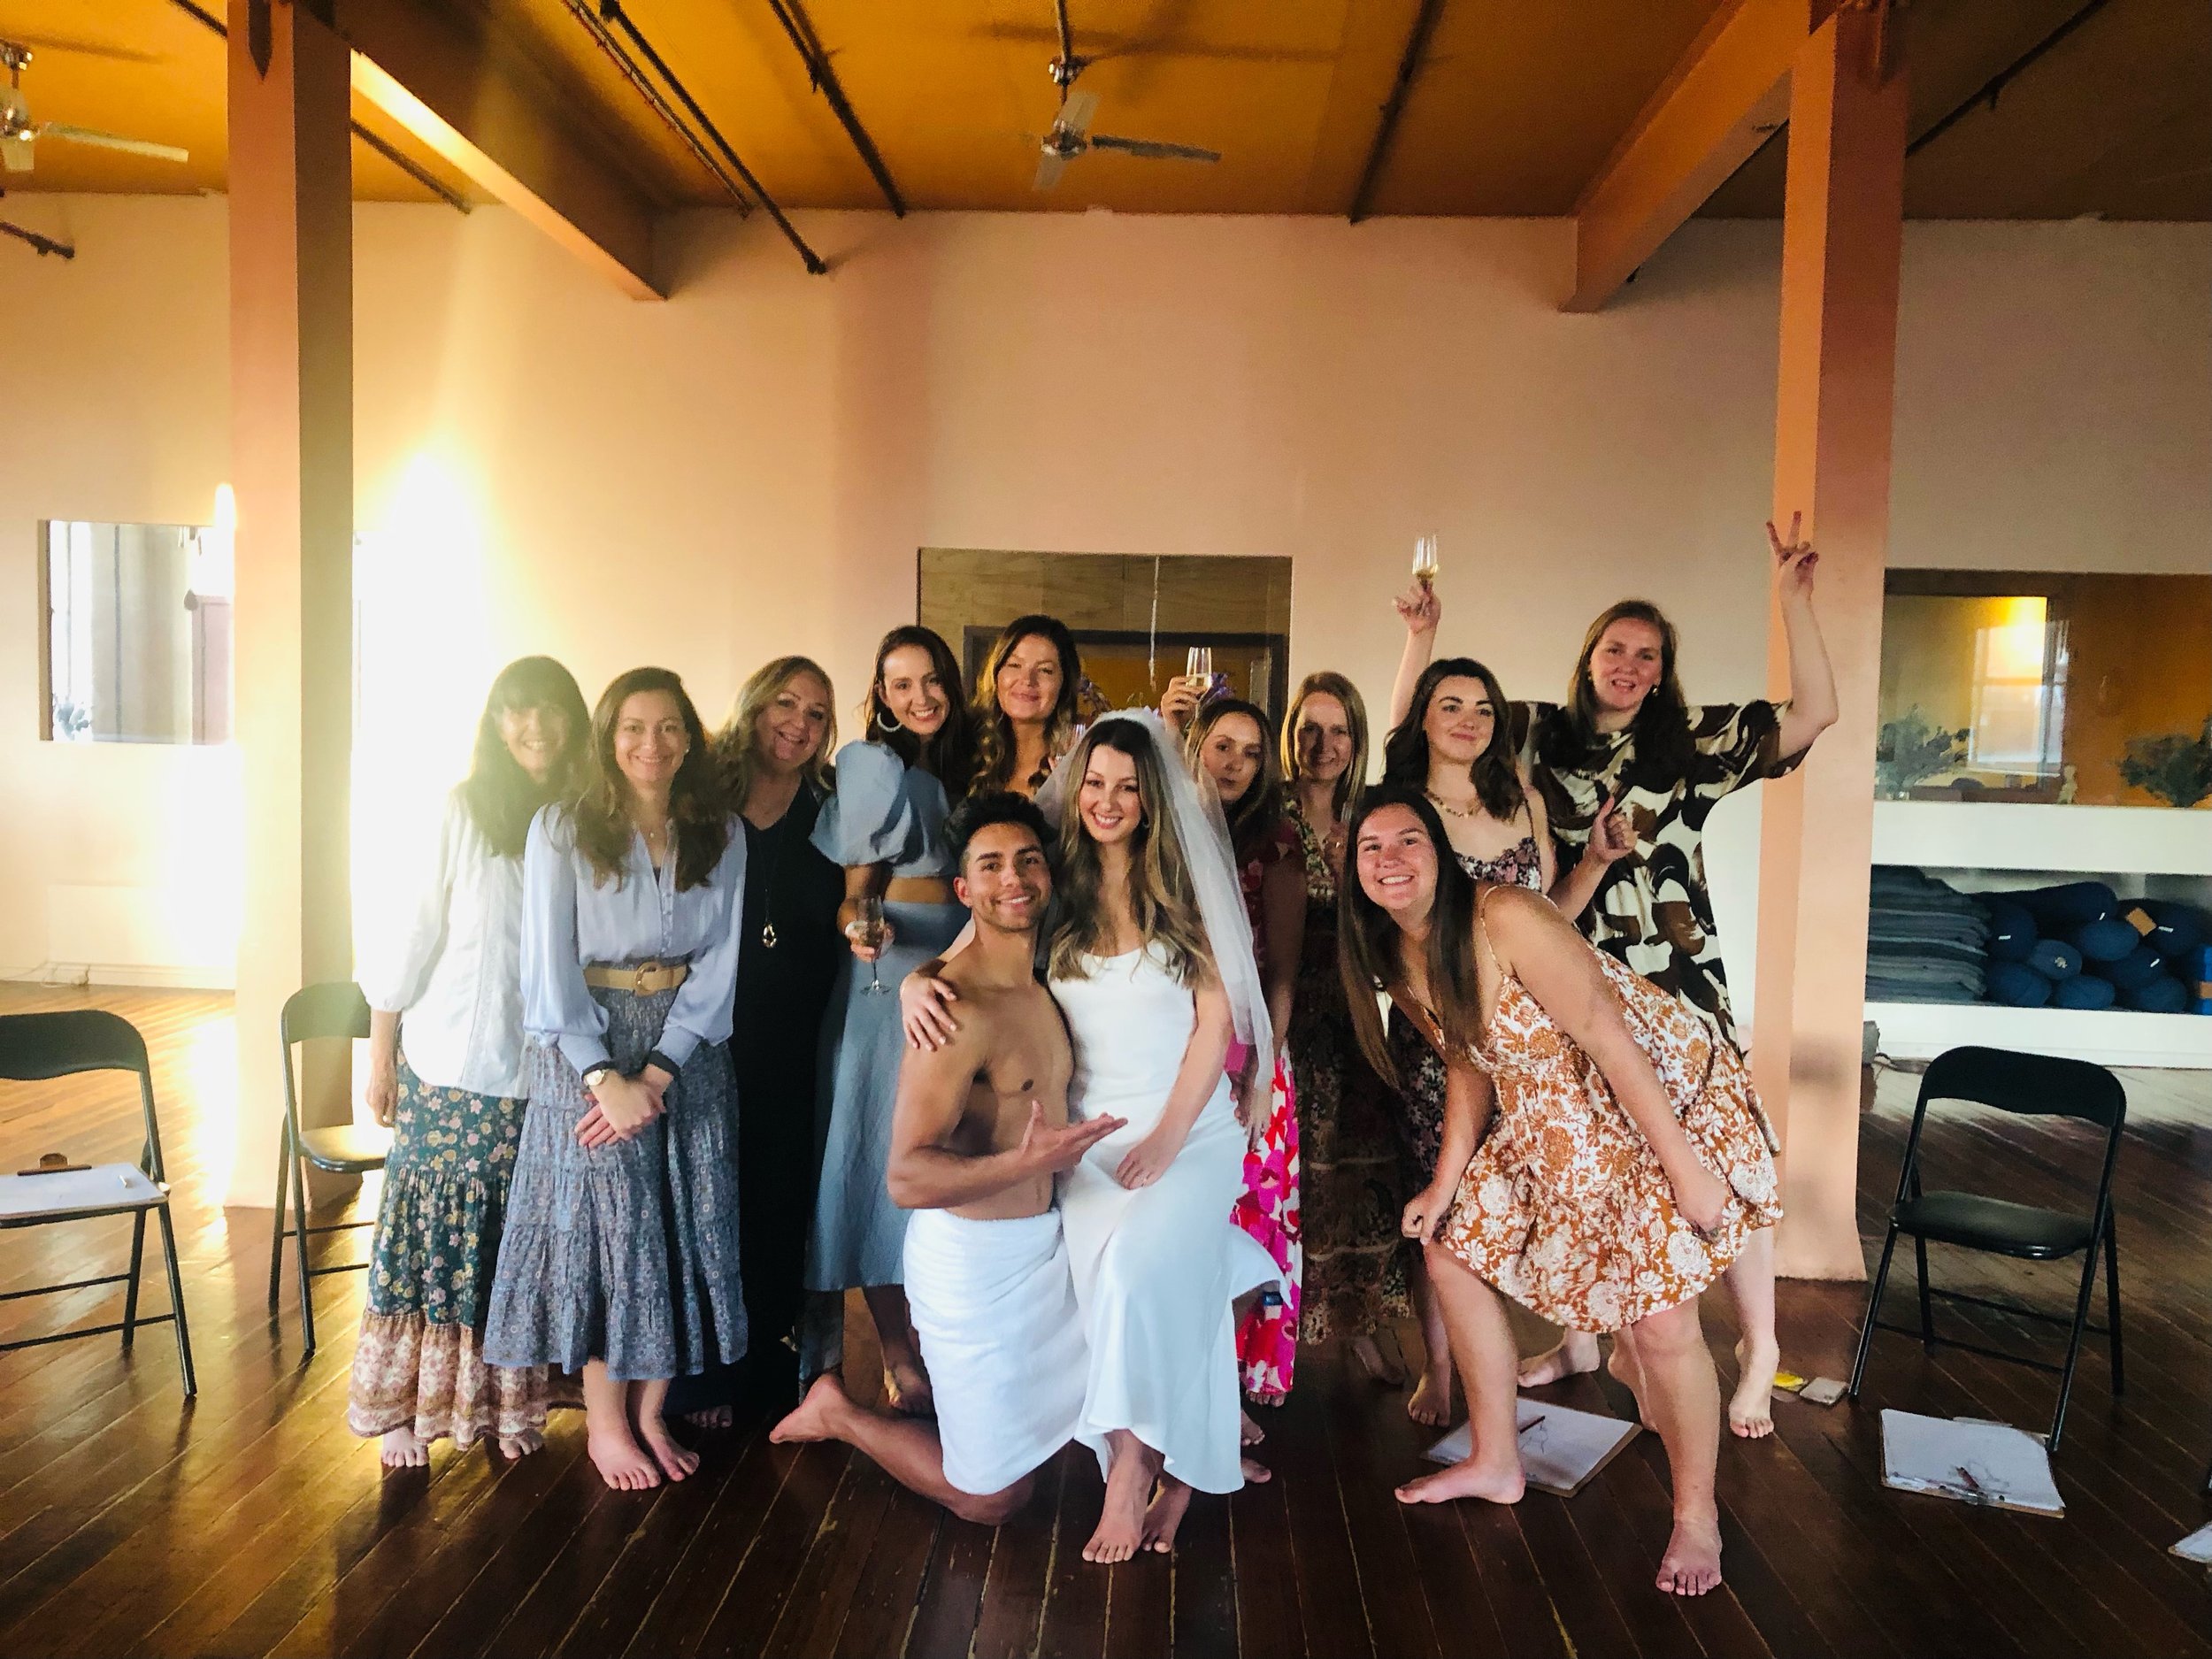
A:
[1051,945,1281,1494]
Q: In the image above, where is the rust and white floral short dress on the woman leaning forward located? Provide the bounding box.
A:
[1429,889,1783,1332]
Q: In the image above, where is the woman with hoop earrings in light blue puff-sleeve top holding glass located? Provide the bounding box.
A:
[803,628,973,1414]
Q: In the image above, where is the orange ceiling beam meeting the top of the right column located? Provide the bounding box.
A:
[1562,0,1834,312]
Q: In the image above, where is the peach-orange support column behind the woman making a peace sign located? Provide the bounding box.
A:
[1752,12,1905,1279]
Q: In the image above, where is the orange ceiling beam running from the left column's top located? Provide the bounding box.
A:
[332,0,666,299]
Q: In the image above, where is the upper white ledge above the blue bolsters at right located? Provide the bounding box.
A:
[1874,801,2212,876]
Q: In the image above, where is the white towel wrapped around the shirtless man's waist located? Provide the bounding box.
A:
[907,1210,1088,1495]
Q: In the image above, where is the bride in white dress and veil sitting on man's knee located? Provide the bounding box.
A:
[1040,712,1279,1562]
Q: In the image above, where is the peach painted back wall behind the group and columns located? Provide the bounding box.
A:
[0,197,2212,1040]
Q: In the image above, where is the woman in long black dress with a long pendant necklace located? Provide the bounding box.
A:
[671,657,845,1427]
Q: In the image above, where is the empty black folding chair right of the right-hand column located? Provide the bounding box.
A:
[1852,1048,2128,1451]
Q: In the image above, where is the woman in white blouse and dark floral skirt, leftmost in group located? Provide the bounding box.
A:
[345,657,591,1469]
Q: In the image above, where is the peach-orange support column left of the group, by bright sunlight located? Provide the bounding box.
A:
[228,0,354,1206]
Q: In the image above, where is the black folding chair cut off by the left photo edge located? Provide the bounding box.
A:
[0,1009,199,1401]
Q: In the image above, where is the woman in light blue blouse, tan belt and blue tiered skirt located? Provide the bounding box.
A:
[485,668,746,1491]
